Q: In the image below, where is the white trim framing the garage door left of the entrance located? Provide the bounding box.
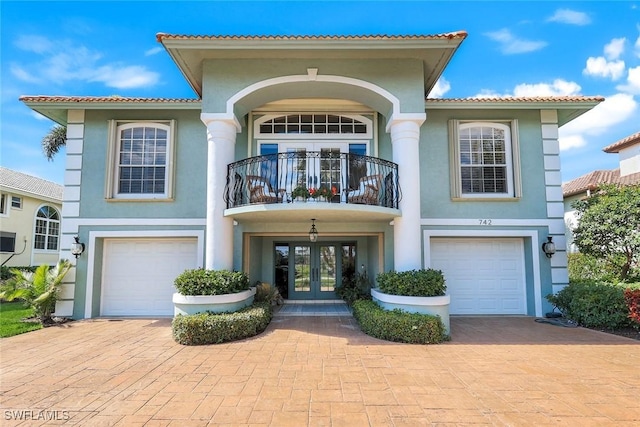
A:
[84,230,204,319]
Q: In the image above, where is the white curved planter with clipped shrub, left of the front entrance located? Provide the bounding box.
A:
[173,268,256,316]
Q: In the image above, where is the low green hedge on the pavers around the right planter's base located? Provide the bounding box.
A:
[353,300,448,344]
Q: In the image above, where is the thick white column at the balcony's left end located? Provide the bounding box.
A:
[202,114,238,270]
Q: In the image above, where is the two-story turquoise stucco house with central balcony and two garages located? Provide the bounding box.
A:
[21,32,603,318]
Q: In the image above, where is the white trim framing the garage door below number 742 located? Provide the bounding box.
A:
[423,230,542,317]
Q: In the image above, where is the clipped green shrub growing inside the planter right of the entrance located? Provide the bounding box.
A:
[377,268,447,297]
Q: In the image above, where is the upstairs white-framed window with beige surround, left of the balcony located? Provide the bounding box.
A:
[106,121,175,200]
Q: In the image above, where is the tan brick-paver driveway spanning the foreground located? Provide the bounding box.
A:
[0,317,640,427]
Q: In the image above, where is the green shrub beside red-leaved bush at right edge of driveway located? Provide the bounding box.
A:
[547,281,640,329]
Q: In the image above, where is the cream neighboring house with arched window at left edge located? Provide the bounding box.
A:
[0,167,64,267]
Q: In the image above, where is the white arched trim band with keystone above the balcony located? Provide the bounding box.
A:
[225,70,401,121]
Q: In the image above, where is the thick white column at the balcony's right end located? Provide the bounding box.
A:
[388,115,425,271]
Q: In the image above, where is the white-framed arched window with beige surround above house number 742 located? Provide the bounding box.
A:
[449,120,522,199]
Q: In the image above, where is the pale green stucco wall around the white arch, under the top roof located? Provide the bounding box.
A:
[202,58,424,117]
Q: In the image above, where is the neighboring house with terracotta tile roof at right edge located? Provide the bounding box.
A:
[562,132,640,252]
